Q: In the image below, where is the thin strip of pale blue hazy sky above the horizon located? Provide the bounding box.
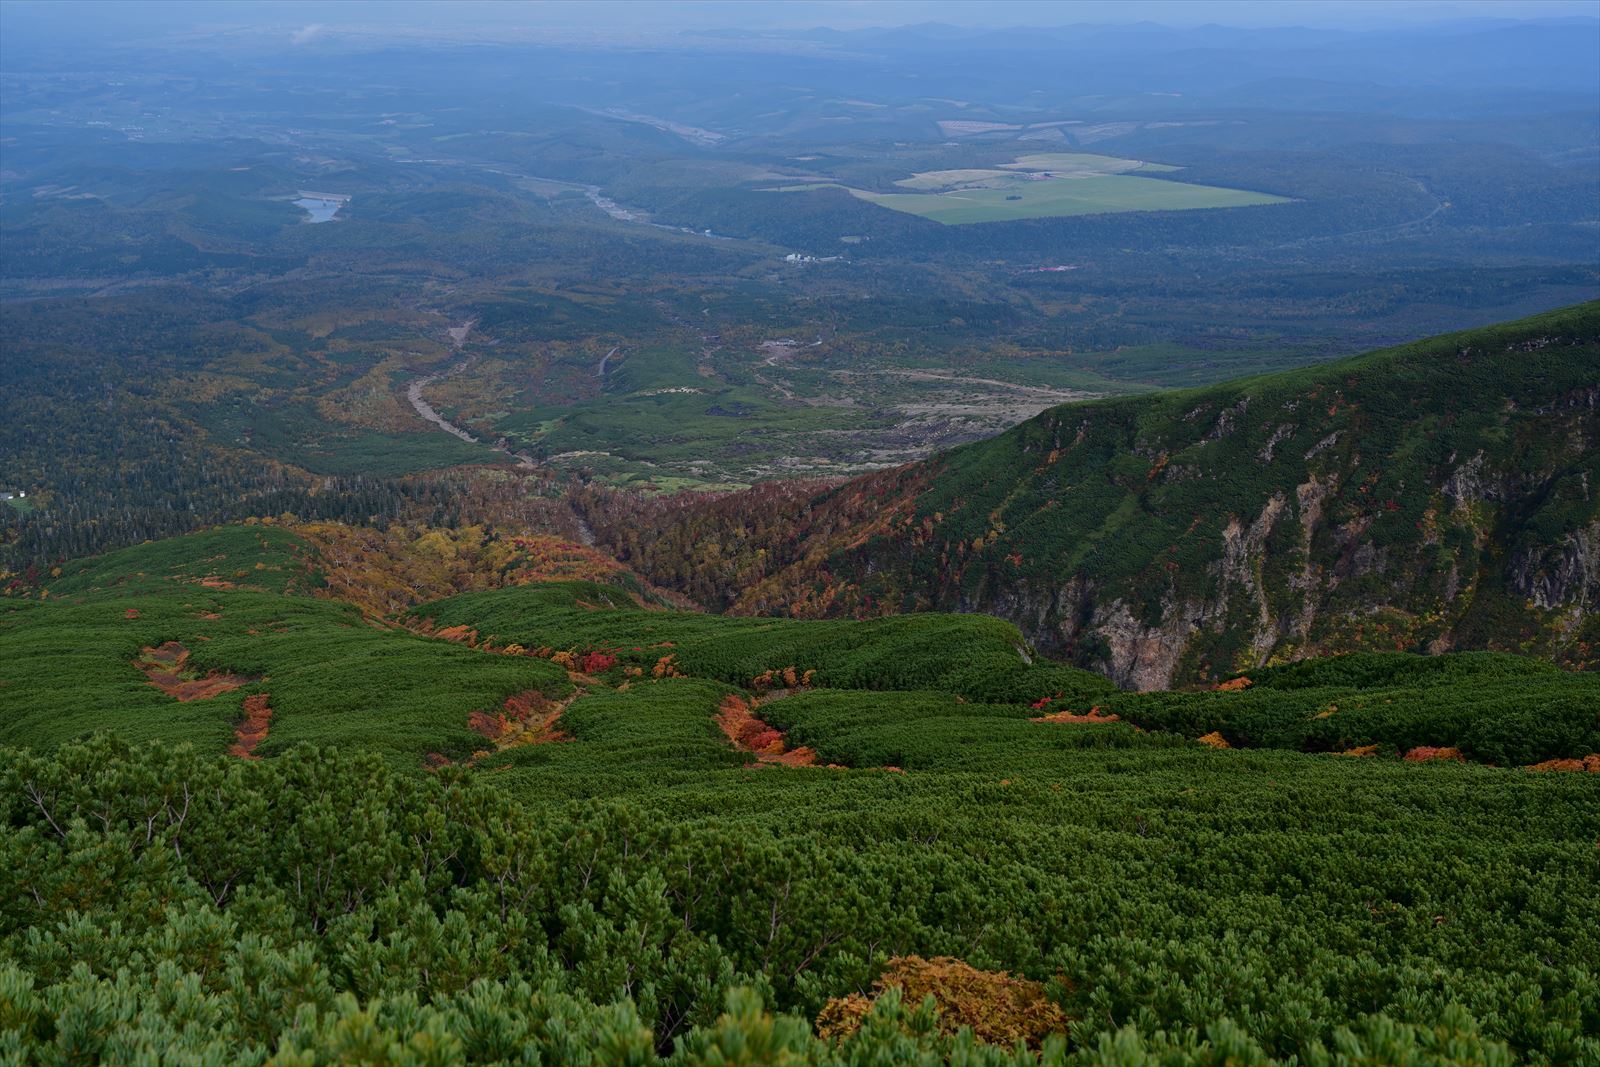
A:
[0,0,1600,38]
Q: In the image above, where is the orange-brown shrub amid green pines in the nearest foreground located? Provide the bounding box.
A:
[816,957,1067,1048]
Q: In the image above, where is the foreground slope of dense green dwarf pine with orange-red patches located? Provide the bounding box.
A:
[0,525,1600,1067]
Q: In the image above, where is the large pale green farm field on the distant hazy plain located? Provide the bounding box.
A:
[774,152,1286,226]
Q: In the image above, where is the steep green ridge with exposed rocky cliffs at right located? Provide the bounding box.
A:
[734,304,1600,689]
